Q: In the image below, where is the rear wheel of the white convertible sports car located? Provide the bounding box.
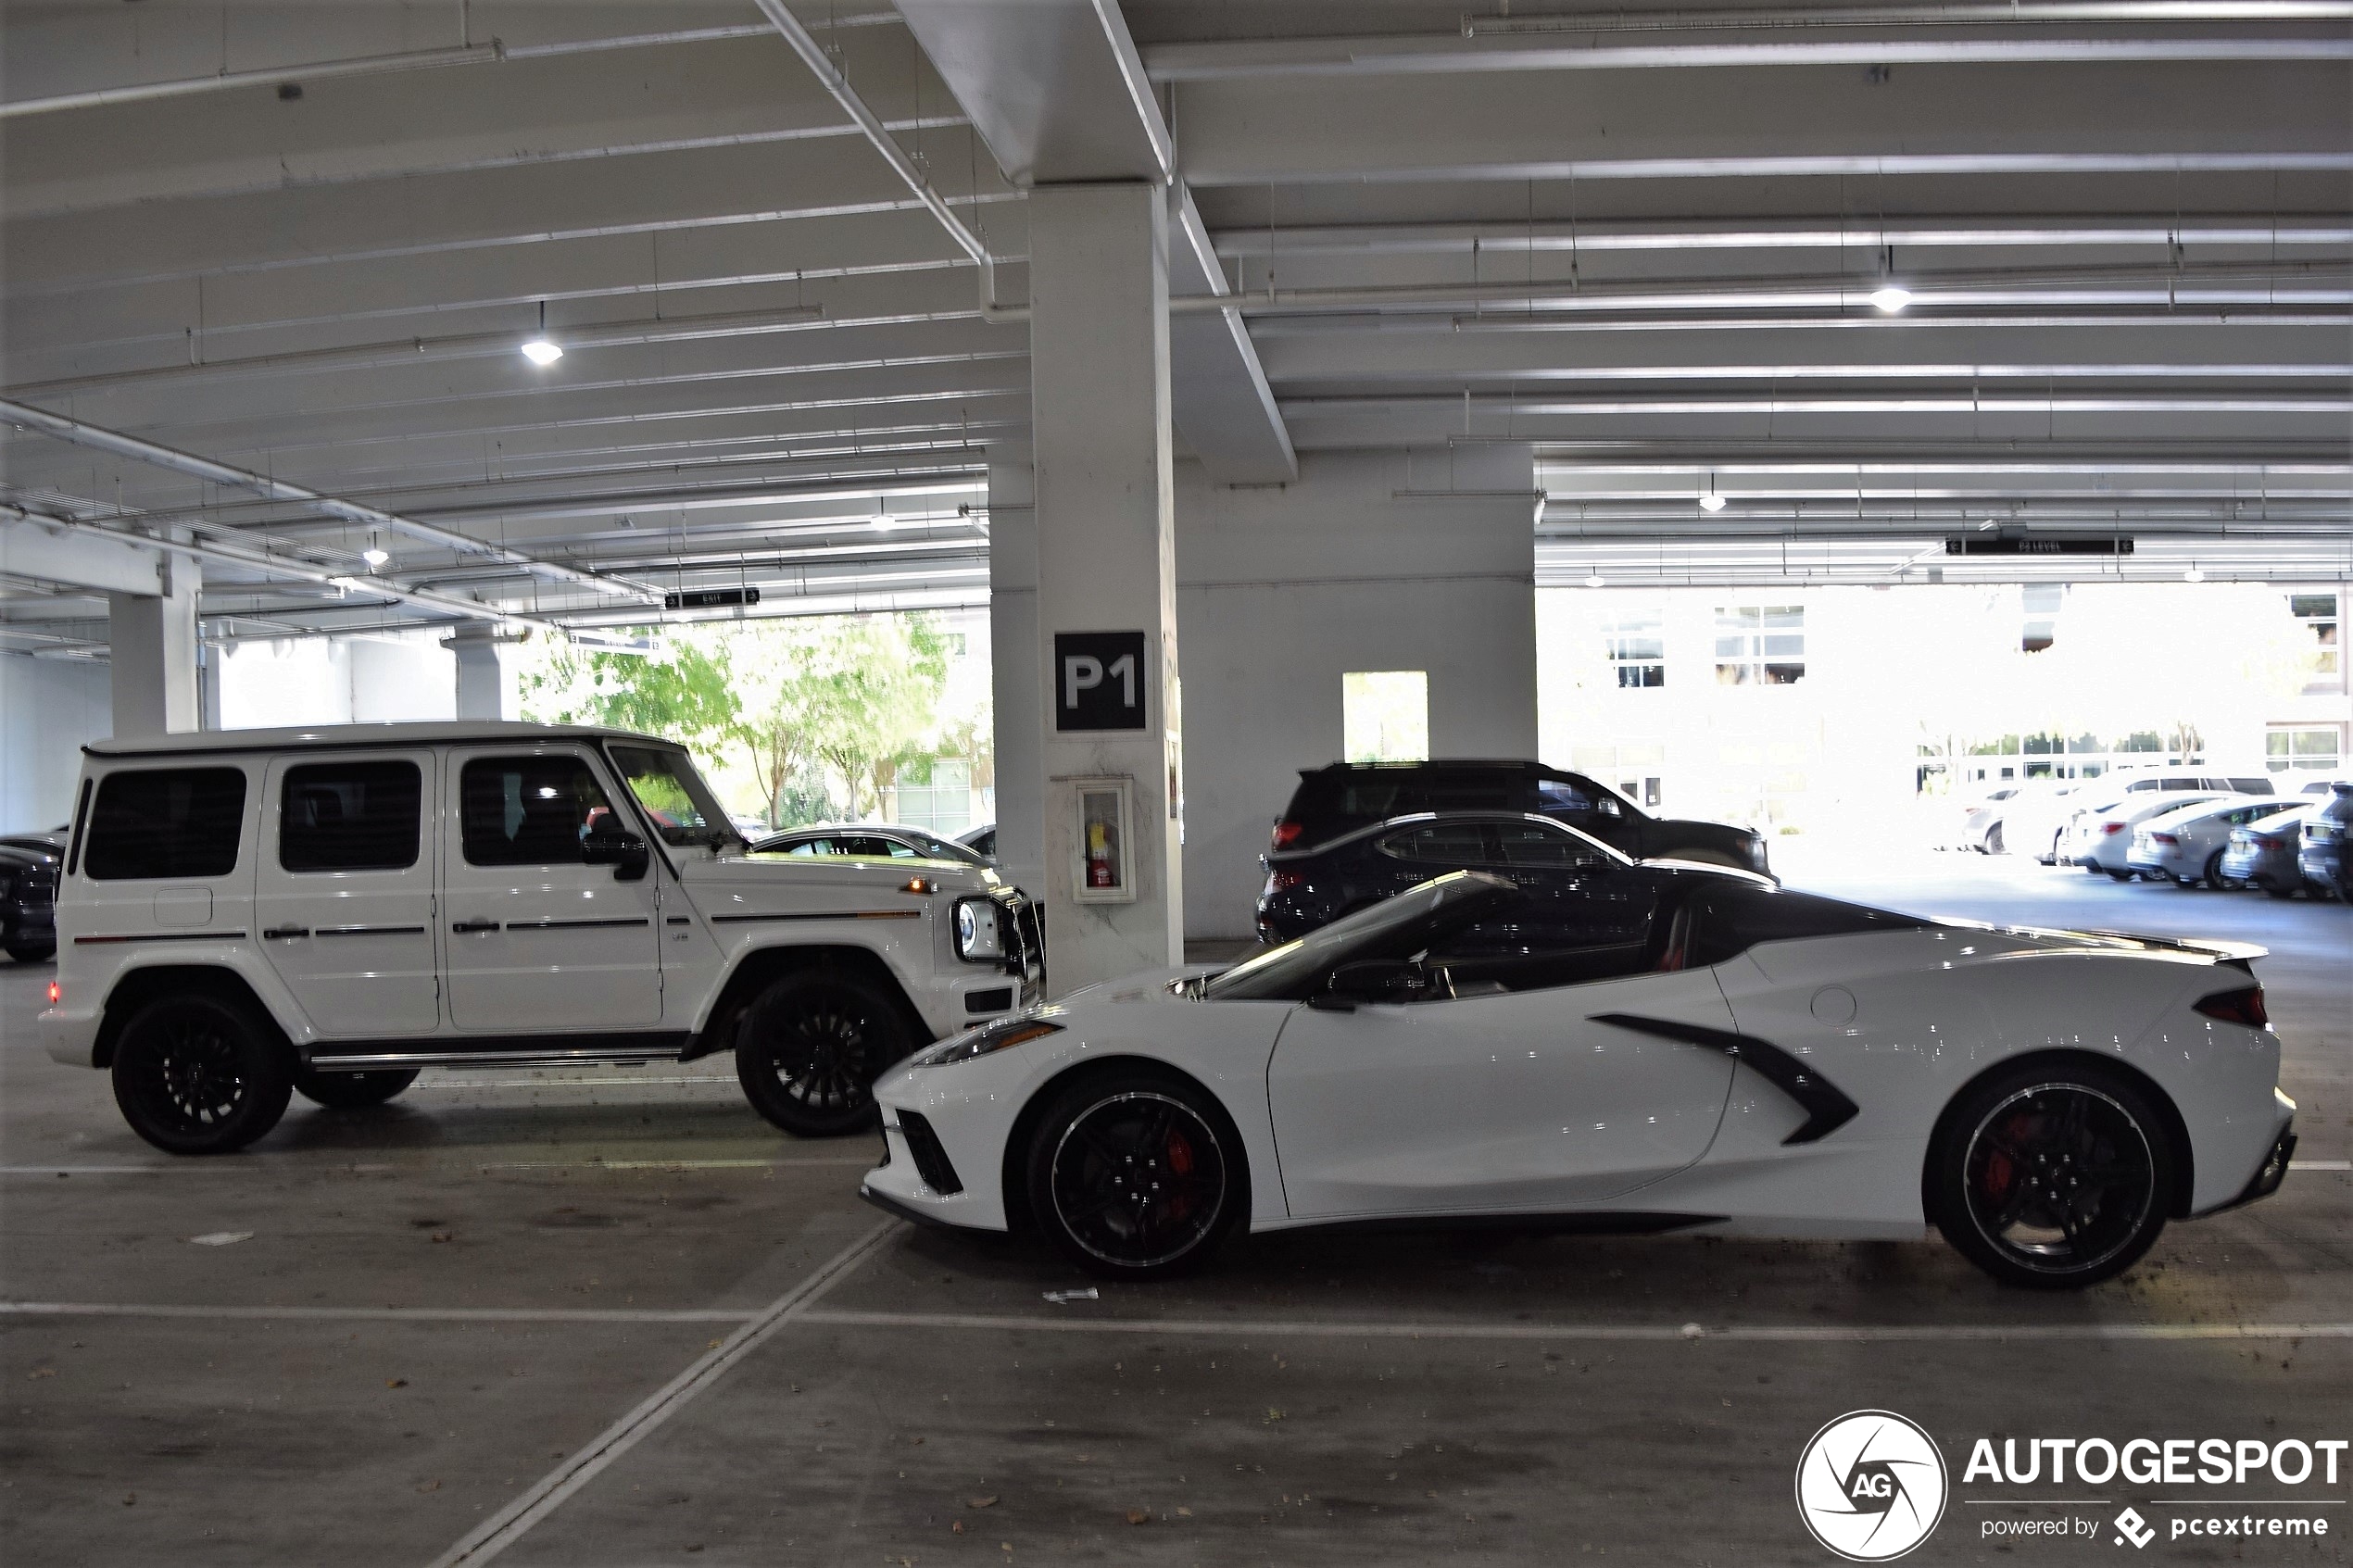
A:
[1927,1062,2174,1290]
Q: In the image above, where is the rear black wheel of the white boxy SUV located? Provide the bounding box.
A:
[113,995,295,1154]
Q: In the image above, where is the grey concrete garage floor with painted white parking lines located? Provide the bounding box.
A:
[0,847,2353,1568]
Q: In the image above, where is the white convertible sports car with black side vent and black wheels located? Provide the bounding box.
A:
[863,868,2295,1286]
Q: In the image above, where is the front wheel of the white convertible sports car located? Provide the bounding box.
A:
[1028,1072,1247,1279]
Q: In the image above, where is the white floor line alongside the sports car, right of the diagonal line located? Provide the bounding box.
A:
[800,1307,2353,1345]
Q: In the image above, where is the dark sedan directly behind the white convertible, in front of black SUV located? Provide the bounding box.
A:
[1259,811,1772,945]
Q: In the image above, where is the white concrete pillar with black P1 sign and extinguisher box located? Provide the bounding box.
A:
[1030,181,1184,992]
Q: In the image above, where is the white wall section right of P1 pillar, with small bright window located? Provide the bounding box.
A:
[1176,446,1537,940]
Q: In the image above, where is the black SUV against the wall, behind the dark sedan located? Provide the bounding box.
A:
[1271,761,1768,872]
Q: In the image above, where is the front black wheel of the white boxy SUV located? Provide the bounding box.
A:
[736,971,915,1138]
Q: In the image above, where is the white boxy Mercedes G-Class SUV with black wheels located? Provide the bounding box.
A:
[40,721,1045,1154]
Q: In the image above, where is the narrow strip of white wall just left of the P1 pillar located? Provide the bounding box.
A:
[988,446,1045,898]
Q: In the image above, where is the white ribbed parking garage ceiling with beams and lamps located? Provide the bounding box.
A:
[0,0,2353,651]
